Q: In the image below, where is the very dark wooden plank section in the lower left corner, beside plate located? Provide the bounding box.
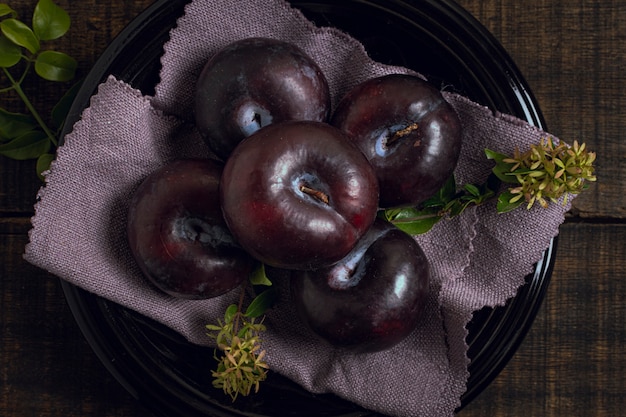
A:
[0,219,152,417]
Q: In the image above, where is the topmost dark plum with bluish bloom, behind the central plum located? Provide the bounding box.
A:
[195,38,330,160]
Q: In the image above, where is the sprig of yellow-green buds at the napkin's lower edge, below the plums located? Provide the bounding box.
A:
[206,265,276,401]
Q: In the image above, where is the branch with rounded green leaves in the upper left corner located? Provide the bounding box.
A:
[0,0,78,177]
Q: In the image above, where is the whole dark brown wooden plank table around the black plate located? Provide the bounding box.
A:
[0,0,626,417]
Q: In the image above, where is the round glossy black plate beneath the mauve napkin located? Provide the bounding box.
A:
[62,0,555,417]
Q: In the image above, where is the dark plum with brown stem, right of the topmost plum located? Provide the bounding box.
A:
[331,74,462,208]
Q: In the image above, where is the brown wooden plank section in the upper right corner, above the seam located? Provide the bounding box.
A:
[458,0,626,219]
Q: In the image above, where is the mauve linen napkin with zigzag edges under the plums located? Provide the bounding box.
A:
[25,0,569,417]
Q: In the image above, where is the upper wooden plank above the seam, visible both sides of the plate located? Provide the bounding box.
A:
[0,0,626,218]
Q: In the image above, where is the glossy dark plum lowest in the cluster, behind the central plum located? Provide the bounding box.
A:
[290,219,430,353]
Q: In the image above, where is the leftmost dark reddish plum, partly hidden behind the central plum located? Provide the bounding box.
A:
[127,159,255,299]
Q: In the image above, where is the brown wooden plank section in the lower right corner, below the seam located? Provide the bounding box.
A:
[460,224,626,417]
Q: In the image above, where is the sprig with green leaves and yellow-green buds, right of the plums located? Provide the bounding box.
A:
[379,138,596,235]
